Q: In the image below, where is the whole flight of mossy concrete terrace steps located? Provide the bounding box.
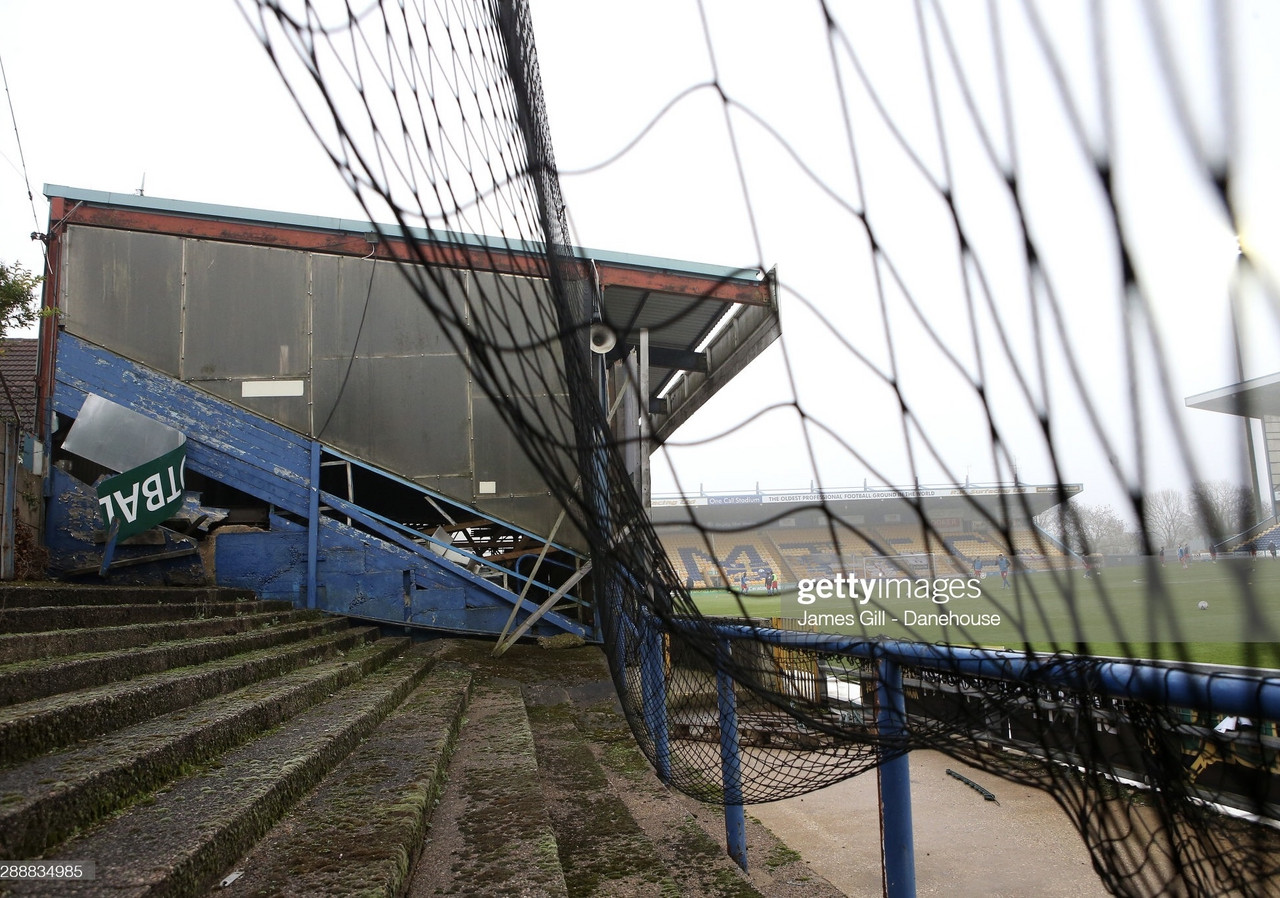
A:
[0,585,838,897]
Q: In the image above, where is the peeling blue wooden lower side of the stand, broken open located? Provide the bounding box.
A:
[45,334,598,641]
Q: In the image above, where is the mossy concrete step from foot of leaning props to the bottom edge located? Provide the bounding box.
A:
[407,679,568,898]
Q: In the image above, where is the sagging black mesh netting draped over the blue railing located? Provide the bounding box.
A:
[241,0,1280,895]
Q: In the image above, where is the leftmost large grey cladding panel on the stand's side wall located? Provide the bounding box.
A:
[60,225,182,376]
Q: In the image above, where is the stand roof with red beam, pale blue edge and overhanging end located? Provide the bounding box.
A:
[44,184,781,444]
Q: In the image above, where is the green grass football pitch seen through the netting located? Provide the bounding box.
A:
[694,555,1280,669]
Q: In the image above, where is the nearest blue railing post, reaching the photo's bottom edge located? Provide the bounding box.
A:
[876,658,915,898]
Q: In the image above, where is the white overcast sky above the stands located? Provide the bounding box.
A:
[0,0,1280,524]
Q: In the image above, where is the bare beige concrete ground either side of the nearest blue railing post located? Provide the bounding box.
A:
[746,751,1107,898]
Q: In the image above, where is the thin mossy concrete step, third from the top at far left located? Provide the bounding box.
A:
[0,609,320,664]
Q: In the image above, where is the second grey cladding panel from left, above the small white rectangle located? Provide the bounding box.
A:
[183,240,311,378]
